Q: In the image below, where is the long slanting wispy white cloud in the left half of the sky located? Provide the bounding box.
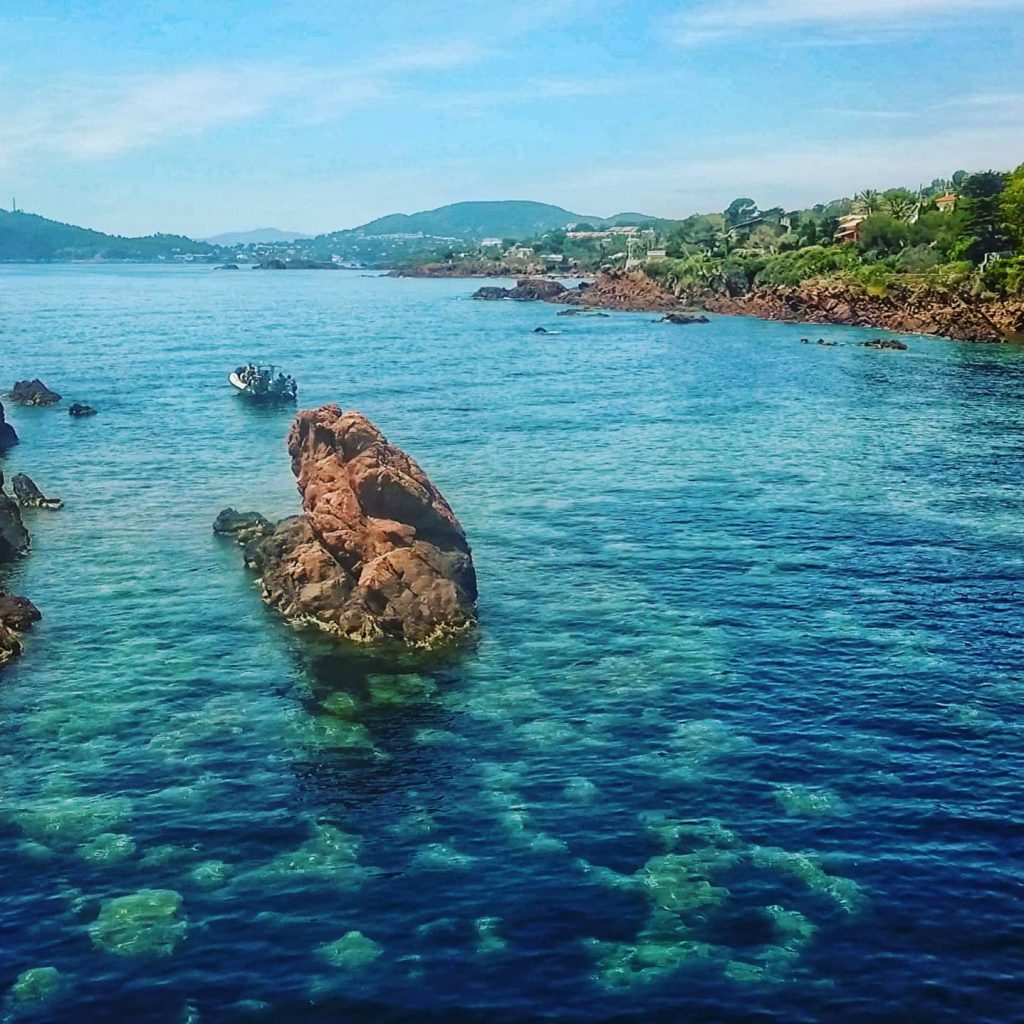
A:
[0,41,486,167]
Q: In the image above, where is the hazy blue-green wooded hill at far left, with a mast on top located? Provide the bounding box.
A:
[0,210,217,261]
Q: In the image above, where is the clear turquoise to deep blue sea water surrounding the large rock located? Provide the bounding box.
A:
[0,267,1024,1024]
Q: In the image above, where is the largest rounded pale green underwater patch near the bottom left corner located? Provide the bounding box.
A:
[89,889,188,956]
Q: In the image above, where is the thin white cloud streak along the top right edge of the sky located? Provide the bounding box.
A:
[670,0,1024,43]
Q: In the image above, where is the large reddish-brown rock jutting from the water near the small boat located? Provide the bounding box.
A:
[222,406,476,646]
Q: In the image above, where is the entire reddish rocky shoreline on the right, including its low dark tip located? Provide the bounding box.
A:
[474,270,1024,343]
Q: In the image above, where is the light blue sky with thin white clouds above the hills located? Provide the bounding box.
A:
[0,0,1024,237]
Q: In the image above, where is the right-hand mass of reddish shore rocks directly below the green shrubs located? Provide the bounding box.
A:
[702,279,1024,342]
